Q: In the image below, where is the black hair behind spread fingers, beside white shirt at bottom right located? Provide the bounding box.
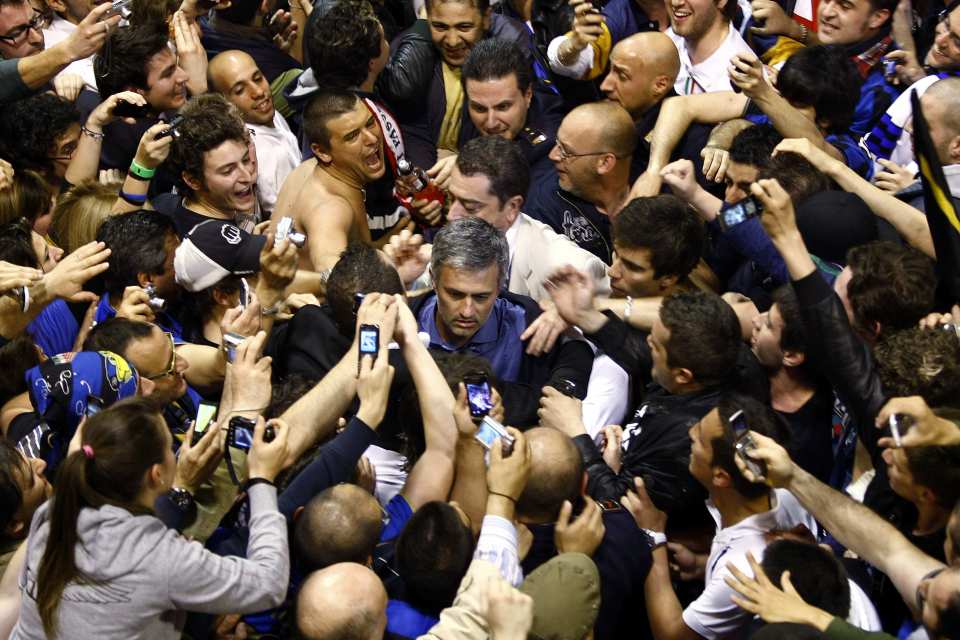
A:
[760,538,850,619]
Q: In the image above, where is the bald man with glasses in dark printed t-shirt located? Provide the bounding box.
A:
[524,102,637,264]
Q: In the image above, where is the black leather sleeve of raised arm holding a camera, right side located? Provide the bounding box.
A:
[793,271,886,457]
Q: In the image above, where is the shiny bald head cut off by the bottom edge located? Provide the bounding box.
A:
[297,562,387,640]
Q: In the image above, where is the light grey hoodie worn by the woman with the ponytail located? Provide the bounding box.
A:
[10,484,290,640]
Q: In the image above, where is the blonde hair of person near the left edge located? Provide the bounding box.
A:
[50,180,117,253]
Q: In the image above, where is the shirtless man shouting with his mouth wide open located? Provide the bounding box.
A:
[271,91,410,271]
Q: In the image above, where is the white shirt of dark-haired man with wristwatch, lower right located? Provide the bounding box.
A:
[683,489,817,640]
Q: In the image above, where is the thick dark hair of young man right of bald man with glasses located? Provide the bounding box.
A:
[611,195,706,280]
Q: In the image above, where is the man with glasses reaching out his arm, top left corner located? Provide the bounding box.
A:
[0,0,120,103]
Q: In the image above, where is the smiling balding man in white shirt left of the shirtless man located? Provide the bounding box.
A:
[207,49,301,216]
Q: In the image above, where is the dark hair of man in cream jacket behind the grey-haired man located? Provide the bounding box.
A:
[457,136,530,207]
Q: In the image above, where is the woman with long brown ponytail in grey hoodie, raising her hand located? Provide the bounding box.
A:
[10,398,290,639]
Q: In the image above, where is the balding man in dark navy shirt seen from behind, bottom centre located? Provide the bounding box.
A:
[516,427,653,640]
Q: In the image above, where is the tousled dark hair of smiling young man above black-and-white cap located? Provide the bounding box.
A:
[168,93,250,192]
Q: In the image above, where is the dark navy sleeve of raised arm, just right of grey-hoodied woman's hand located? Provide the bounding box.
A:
[277,416,377,521]
